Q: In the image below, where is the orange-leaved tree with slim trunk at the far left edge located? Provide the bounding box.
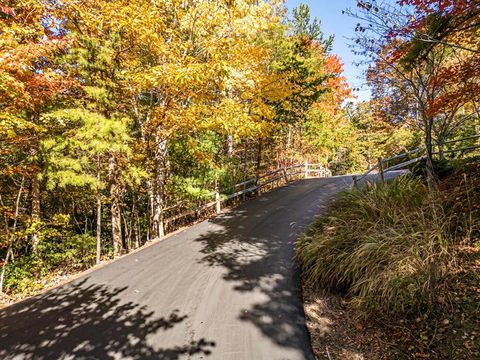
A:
[0,0,71,252]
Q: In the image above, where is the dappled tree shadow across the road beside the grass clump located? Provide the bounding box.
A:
[193,184,324,359]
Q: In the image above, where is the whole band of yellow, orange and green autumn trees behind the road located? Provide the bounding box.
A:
[0,0,480,298]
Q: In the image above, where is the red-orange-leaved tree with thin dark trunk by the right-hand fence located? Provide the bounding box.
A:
[350,1,478,178]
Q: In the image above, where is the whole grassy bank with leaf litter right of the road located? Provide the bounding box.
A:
[298,160,480,359]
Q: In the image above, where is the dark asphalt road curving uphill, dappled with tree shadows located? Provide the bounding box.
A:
[0,177,351,360]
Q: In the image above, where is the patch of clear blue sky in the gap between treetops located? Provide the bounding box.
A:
[286,0,370,101]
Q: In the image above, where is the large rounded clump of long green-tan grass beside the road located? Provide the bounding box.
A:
[297,177,455,316]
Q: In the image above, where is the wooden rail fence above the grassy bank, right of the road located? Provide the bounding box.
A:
[352,135,480,186]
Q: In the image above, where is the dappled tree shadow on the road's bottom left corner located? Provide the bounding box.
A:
[0,278,215,360]
